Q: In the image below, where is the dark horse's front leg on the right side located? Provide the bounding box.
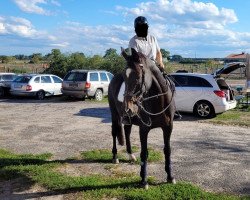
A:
[162,123,176,184]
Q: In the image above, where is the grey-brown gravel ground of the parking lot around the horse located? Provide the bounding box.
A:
[0,97,250,199]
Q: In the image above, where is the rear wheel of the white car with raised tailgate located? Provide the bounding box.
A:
[194,101,215,118]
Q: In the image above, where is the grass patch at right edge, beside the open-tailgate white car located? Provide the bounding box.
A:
[206,106,250,127]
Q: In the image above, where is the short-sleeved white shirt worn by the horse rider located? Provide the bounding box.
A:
[128,35,160,60]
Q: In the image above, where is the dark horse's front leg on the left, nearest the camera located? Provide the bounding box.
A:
[140,127,149,189]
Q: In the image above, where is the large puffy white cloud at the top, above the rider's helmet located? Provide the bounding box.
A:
[117,0,238,29]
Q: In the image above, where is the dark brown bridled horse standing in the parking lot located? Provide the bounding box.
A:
[108,48,175,189]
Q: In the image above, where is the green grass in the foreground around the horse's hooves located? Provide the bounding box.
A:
[0,150,250,200]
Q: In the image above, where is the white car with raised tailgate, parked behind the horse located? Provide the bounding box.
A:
[169,63,245,118]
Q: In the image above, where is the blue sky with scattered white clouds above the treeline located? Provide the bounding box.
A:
[0,0,250,58]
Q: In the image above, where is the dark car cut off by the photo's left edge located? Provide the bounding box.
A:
[0,73,17,97]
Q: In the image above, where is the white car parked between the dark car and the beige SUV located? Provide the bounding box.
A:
[10,74,62,100]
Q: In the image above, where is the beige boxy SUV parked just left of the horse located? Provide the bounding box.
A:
[62,70,113,101]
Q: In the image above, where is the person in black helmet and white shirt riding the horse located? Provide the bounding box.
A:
[129,16,164,72]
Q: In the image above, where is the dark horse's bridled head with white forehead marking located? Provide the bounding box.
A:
[122,48,152,117]
